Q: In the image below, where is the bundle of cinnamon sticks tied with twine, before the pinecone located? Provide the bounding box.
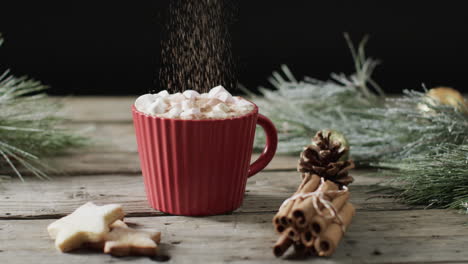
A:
[273,175,355,257]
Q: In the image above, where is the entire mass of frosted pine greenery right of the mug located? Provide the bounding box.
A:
[244,35,468,209]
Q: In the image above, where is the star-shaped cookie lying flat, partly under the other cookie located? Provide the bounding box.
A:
[104,226,161,256]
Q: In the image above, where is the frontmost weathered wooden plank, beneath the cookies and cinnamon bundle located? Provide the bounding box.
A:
[0,210,468,264]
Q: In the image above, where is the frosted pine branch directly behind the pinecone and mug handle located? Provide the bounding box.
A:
[247,34,384,161]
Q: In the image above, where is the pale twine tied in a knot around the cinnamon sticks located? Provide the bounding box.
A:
[280,178,348,233]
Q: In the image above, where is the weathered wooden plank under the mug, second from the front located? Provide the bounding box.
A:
[0,172,398,218]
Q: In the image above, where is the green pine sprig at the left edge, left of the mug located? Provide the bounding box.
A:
[0,35,86,180]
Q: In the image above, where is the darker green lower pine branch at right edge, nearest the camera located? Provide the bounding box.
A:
[380,143,468,209]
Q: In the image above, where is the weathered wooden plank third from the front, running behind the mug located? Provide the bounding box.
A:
[0,120,297,175]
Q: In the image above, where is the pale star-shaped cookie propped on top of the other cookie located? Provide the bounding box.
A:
[47,202,125,252]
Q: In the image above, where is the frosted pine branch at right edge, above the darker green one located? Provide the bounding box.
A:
[362,90,468,161]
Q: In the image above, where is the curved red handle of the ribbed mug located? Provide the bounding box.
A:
[247,114,278,178]
